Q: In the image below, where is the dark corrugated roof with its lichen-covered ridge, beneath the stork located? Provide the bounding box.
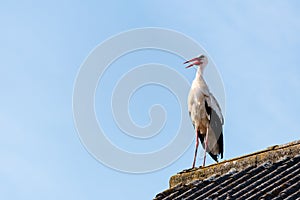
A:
[154,140,300,200]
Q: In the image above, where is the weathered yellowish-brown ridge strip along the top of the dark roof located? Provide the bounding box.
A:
[169,140,300,190]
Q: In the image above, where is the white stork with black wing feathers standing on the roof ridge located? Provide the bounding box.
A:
[184,54,224,168]
